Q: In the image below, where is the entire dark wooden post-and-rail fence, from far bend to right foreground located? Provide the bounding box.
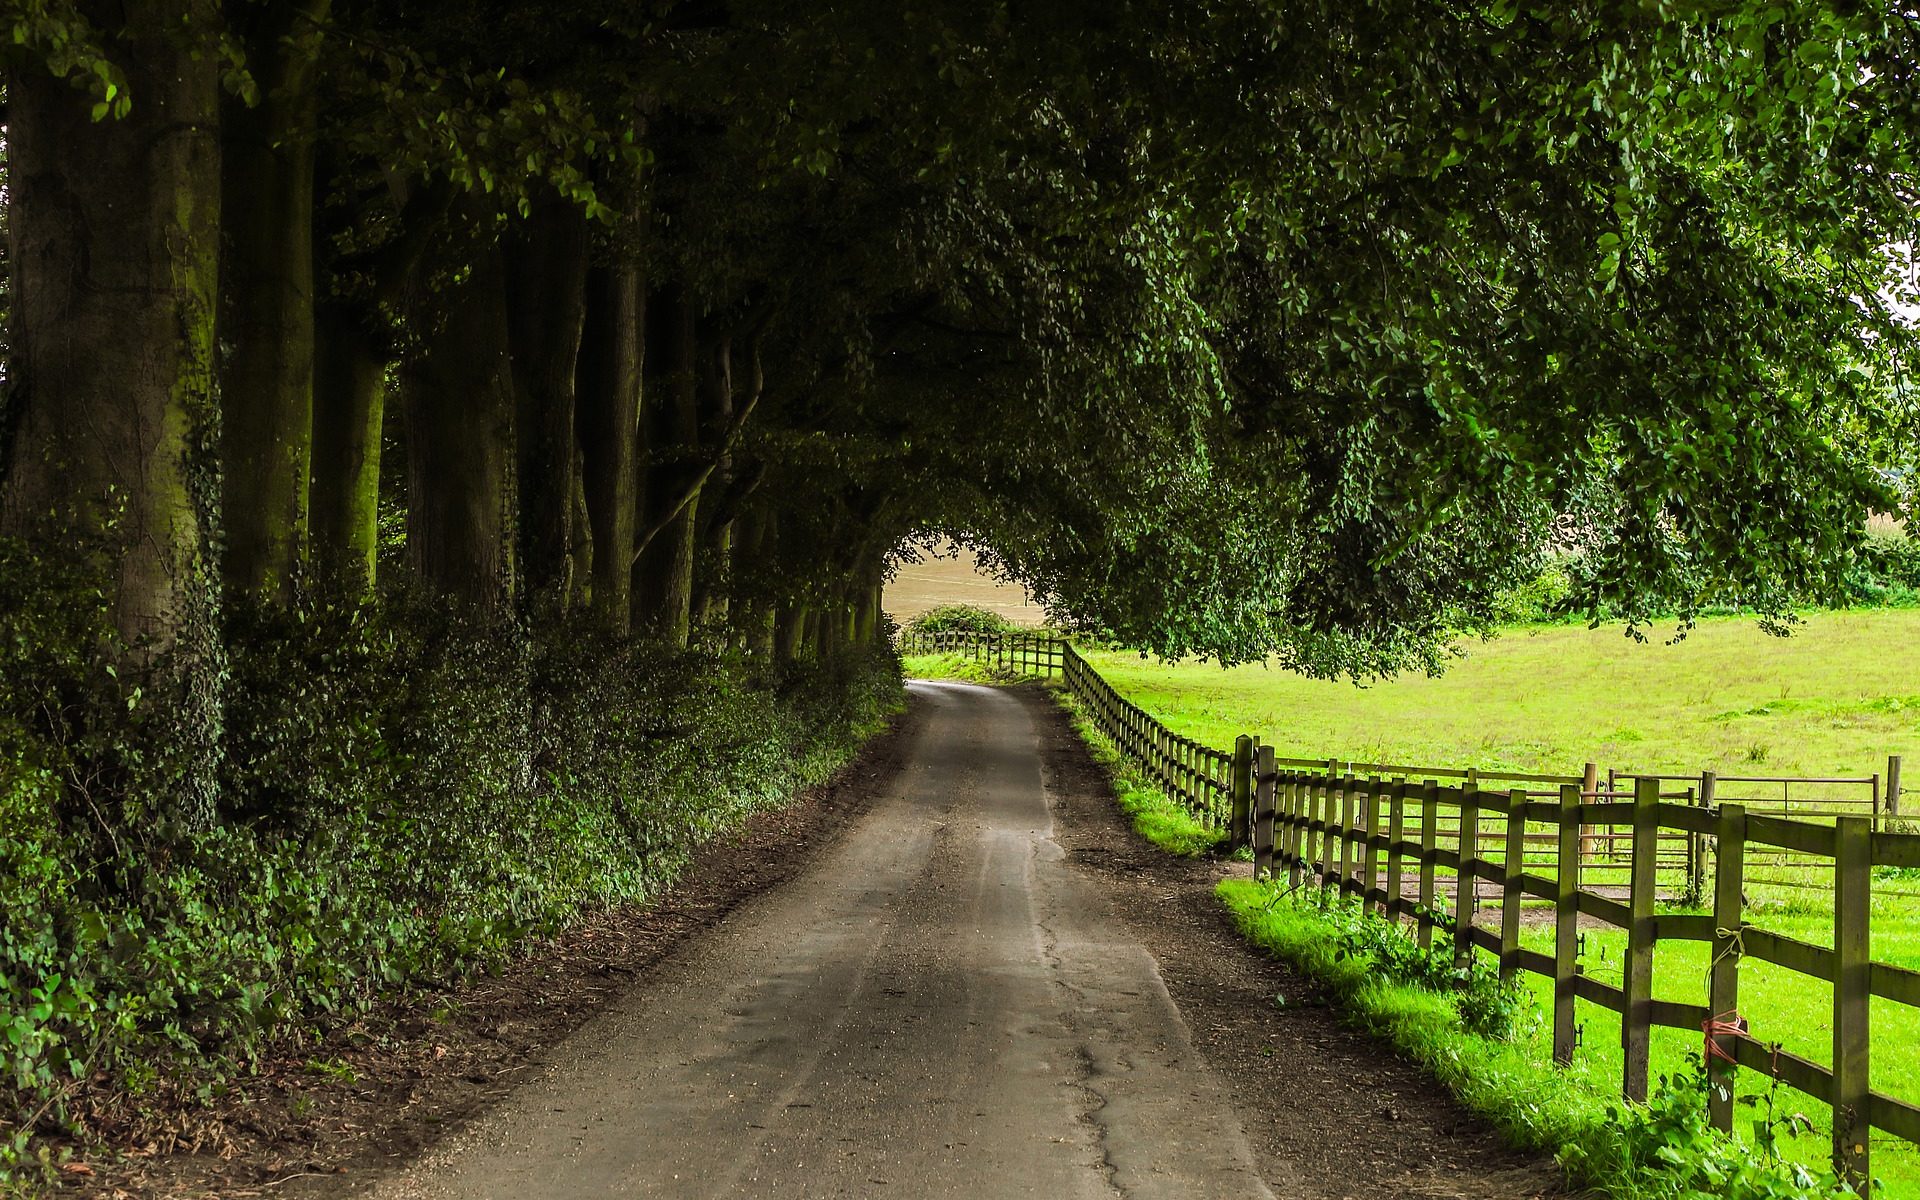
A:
[906,636,1920,1181]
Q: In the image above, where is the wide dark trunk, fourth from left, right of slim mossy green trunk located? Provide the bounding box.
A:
[405,236,516,614]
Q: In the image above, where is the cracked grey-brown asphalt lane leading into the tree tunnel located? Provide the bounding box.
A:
[374,684,1271,1200]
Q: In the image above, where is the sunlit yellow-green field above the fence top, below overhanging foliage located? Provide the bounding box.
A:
[1089,609,1920,808]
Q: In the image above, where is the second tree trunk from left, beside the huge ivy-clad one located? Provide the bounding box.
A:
[221,0,328,597]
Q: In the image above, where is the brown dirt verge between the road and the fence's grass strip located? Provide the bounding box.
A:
[1020,687,1569,1200]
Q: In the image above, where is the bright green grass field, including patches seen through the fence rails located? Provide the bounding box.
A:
[1089,611,1920,1196]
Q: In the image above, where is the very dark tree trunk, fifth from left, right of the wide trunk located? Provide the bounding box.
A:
[505,194,588,607]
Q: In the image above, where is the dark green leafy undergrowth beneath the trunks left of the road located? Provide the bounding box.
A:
[0,559,900,1190]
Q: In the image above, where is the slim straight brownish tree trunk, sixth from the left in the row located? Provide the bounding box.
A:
[578,265,645,634]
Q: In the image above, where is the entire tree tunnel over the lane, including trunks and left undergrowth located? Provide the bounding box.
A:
[0,0,1920,1159]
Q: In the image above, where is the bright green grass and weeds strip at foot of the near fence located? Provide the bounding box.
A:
[1219,879,1855,1200]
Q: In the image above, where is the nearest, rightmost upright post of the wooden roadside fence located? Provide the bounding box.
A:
[1834,816,1874,1188]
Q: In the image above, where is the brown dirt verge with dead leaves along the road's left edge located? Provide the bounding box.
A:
[56,703,925,1198]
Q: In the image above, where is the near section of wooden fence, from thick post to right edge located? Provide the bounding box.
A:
[1252,747,1920,1181]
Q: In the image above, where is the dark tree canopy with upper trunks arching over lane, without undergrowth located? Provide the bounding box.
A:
[0,0,1920,674]
